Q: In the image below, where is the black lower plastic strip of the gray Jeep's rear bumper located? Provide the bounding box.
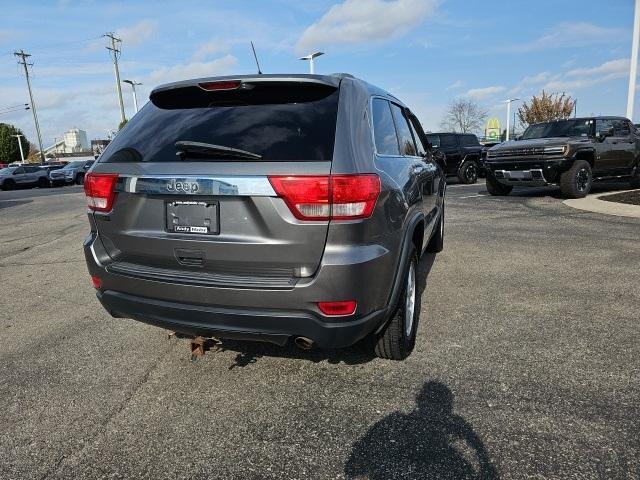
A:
[97,290,386,348]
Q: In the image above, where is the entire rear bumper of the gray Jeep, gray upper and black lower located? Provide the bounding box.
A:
[84,233,400,348]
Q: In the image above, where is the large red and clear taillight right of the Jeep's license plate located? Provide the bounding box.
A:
[269,174,380,220]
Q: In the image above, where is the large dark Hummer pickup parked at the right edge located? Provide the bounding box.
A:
[486,117,640,198]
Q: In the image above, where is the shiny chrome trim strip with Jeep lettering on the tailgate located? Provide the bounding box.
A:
[116,175,277,197]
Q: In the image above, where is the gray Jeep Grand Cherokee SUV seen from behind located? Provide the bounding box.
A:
[84,75,445,359]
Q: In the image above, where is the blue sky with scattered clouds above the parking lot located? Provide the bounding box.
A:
[0,0,640,145]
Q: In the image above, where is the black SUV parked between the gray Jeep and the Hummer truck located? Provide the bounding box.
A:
[427,133,482,183]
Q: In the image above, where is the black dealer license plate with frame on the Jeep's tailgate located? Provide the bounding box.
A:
[166,201,220,235]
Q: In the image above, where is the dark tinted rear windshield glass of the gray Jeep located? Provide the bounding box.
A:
[99,82,339,162]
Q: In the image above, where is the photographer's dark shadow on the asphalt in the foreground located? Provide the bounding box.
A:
[344,382,498,480]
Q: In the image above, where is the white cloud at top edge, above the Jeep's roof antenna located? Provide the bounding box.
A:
[296,0,438,53]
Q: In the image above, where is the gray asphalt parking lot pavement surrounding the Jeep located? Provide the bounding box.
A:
[0,183,640,479]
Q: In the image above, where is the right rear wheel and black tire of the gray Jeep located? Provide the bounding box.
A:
[370,247,420,360]
